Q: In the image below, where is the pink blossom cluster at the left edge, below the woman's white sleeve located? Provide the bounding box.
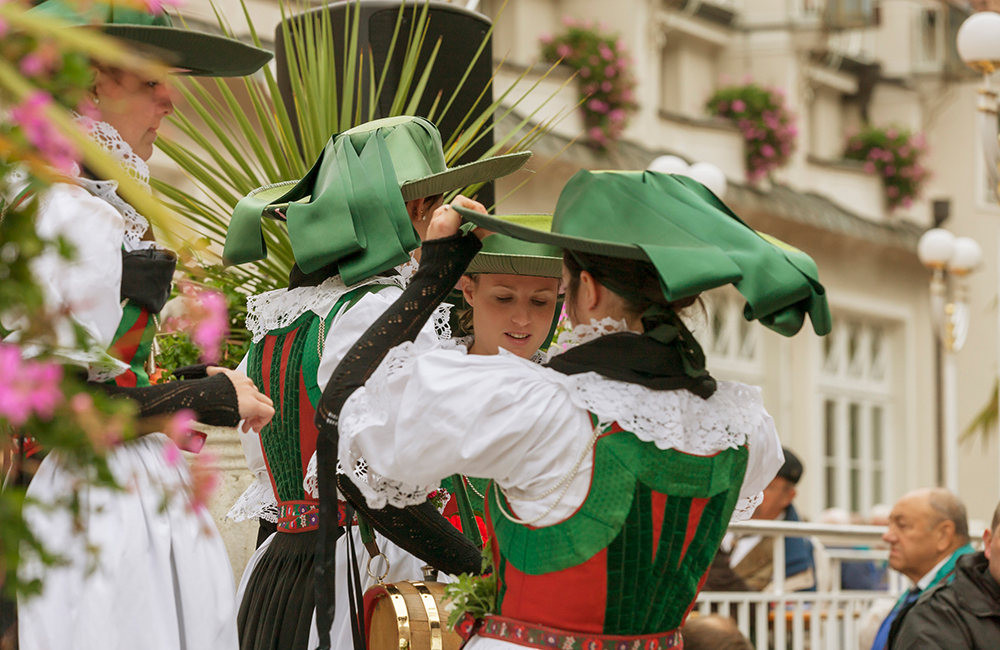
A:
[0,343,63,426]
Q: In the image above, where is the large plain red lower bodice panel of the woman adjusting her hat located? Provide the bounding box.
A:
[500,549,608,634]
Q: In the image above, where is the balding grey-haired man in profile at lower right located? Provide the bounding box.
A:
[872,488,973,650]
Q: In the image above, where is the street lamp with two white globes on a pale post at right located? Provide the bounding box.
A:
[917,228,983,494]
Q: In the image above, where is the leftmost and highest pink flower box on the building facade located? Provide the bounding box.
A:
[539,16,638,151]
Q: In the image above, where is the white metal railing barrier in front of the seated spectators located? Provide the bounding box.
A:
[697,520,906,650]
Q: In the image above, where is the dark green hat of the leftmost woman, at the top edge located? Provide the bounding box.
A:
[31,0,274,77]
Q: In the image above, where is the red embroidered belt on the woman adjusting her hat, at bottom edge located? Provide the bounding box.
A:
[476,615,684,650]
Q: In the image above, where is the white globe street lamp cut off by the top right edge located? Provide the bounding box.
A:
[956,11,1000,492]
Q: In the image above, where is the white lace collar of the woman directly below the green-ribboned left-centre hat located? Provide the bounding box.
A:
[246,256,428,343]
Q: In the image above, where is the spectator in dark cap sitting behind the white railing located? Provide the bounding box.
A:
[720,449,816,591]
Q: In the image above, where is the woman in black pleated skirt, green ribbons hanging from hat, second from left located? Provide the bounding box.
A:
[224,117,530,650]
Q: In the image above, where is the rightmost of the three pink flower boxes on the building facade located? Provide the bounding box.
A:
[844,126,930,210]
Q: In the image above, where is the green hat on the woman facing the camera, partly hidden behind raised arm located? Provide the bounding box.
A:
[465,214,562,278]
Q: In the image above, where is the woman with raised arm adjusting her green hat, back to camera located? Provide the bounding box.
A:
[317,171,830,650]
